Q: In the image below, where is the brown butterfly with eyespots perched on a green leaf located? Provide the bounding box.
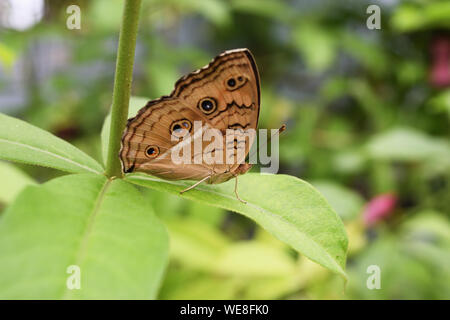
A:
[120,49,260,202]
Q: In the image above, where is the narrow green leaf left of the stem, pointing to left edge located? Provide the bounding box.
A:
[0,114,103,173]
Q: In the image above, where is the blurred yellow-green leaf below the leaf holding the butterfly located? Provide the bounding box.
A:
[167,219,295,277]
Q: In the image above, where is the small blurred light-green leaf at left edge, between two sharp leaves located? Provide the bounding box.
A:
[0,162,35,204]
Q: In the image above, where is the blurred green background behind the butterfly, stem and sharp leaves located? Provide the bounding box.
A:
[0,0,450,299]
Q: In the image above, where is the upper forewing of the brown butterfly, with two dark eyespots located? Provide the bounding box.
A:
[172,49,260,129]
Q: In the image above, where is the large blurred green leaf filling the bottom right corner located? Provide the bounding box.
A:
[348,211,450,299]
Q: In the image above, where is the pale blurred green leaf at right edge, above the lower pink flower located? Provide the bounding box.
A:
[366,128,450,162]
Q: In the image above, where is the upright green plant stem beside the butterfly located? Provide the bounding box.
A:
[106,0,141,177]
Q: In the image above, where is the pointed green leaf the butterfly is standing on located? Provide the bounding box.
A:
[126,173,348,278]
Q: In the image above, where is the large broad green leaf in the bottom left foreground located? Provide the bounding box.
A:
[0,174,168,299]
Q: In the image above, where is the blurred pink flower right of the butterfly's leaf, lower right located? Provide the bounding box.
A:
[363,193,397,226]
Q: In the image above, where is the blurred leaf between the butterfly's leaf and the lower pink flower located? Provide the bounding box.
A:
[311,180,364,221]
